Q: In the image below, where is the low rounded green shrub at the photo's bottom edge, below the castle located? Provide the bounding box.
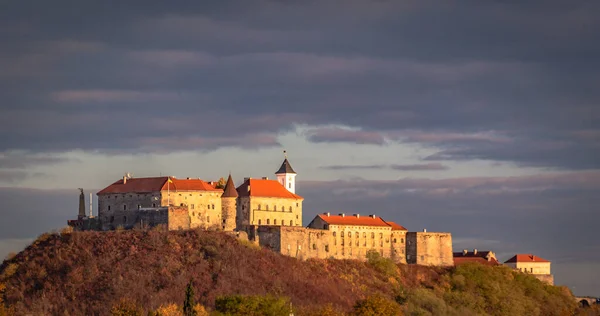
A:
[215,295,291,316]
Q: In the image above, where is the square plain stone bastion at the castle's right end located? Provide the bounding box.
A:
[406,232,454,266]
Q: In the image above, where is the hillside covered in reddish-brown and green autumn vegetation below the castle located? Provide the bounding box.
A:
[0,230,576,315]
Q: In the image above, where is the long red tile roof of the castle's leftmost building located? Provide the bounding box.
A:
[97,177,222,195]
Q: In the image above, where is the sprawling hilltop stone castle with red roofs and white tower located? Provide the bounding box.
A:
[68,157,453,266]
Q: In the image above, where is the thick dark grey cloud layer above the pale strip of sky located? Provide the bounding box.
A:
[0,0,600,169]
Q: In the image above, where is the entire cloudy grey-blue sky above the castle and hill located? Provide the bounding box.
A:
[0,0,600,296]
